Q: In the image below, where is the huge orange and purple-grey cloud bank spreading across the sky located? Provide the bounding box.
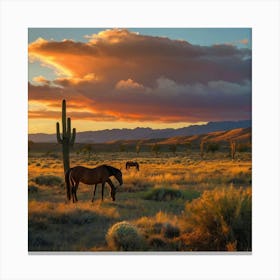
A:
[29,29,251,125]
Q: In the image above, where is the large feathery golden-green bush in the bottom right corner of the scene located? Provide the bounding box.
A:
[184,186,252,251]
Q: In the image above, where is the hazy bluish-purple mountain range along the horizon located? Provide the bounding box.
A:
[28,120,252,143]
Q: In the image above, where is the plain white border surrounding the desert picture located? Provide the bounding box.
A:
[0,0,280,280]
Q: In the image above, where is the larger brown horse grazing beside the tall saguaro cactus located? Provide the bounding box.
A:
[65,165,123,203]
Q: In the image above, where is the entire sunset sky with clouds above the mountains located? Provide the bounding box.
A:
[28,28,252,133]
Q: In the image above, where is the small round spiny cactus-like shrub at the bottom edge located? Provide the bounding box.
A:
[106,221,144,251]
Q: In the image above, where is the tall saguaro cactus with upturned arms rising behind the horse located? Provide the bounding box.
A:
[56,99,76,173]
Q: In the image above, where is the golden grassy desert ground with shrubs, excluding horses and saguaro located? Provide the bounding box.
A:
[28,149,252,252]
